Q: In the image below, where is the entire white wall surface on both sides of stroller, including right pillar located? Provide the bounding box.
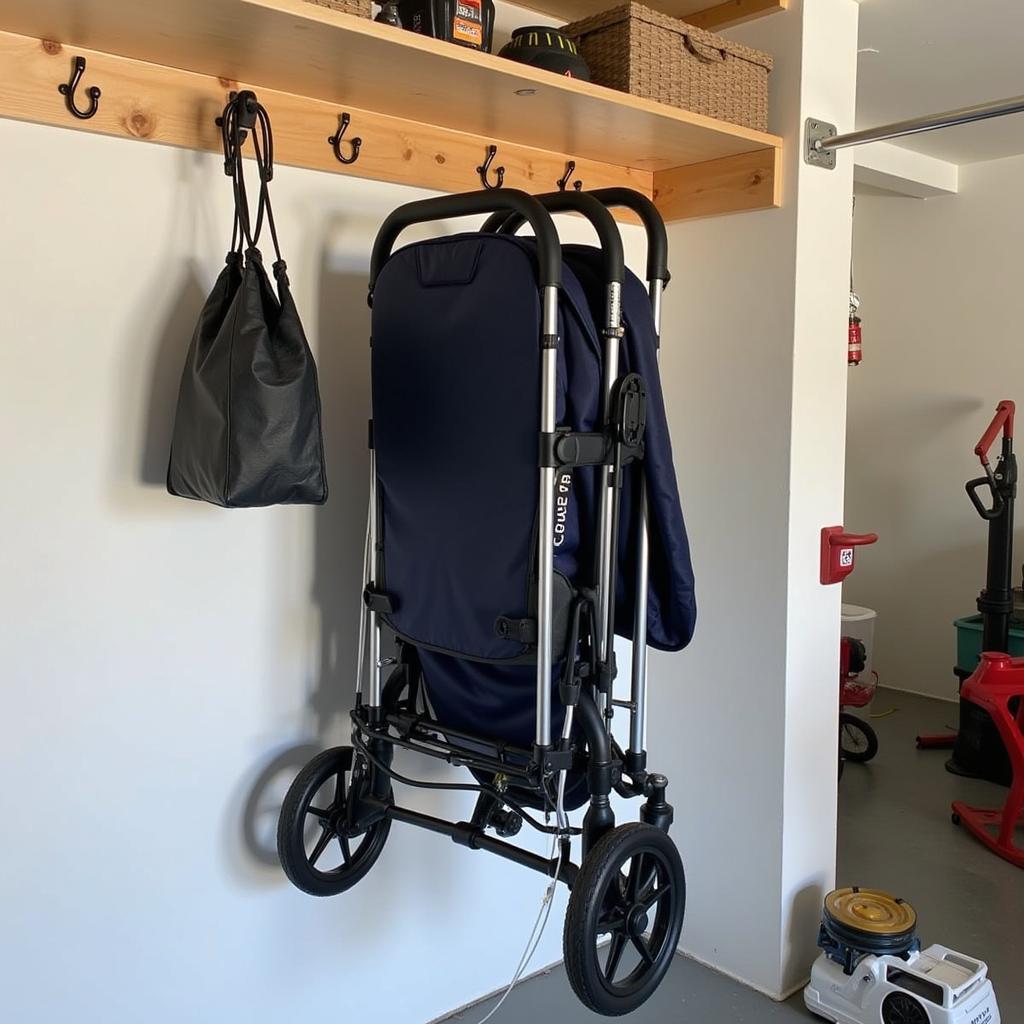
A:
[0,0,856,1011]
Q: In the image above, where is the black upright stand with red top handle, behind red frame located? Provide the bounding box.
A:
[918,401,1017,783]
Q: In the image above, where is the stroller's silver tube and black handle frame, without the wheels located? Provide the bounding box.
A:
[351,188,669,860]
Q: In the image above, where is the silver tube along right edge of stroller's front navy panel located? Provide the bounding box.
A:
[536,286,558,746]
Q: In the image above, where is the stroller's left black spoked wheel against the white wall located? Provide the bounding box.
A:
[278,746,391,896]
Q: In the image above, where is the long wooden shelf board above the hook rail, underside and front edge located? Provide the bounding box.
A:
[0,0,780,171]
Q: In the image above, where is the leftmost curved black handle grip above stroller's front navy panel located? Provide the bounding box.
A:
[370,188,562,294]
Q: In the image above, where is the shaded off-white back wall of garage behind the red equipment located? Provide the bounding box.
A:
[844,151,1024,698]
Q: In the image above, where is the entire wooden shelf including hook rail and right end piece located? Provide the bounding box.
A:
[0,0,781,217]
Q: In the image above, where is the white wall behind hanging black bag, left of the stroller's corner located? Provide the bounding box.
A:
[0,112,643,1024]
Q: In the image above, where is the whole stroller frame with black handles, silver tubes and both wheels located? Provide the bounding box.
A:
[278,188,685,1015]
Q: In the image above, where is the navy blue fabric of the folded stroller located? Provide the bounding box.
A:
[372,233,693,790]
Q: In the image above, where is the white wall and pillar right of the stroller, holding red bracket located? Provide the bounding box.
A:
[651,0,857,996]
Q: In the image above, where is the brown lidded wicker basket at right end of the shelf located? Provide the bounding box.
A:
[562,3,772,131]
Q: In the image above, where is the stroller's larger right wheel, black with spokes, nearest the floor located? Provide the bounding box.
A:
[563,822,686,1017]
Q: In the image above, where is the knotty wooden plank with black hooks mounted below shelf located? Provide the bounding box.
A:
[0,33,652,203]
